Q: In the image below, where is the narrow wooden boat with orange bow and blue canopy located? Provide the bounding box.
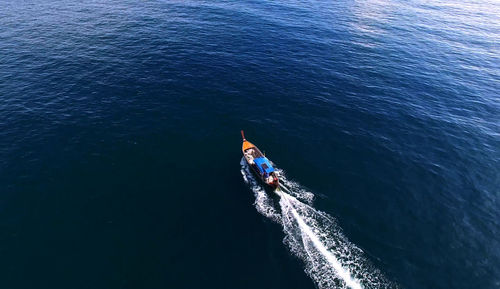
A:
[241,131,279,190]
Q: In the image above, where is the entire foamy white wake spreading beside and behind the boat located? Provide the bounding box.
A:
[240,159,397,289]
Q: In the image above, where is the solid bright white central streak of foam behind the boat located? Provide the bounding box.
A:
[278,192,362,289]
